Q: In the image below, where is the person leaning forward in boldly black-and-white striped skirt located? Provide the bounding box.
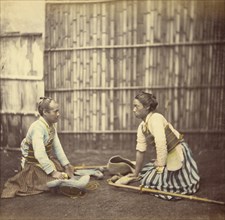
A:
[133,92,200,200]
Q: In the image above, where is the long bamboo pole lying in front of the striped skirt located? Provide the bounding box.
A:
[108,180,225,205]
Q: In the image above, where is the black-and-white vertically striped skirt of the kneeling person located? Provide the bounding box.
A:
[141,142,200,200]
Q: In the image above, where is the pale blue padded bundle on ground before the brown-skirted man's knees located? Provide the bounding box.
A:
[47,175,90,189]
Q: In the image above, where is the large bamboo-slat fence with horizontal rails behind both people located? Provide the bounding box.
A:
[44,0,225,149]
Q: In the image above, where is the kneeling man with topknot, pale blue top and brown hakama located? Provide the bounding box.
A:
[1,97,74,198]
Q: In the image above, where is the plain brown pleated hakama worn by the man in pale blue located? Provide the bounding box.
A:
[1,158,63,198]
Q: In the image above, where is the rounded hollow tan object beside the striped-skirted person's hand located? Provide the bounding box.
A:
[107,155,135,175]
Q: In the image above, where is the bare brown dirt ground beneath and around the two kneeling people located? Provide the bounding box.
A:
[0,149,225,220]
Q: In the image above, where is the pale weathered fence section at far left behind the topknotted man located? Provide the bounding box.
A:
[0,33,44,150]
